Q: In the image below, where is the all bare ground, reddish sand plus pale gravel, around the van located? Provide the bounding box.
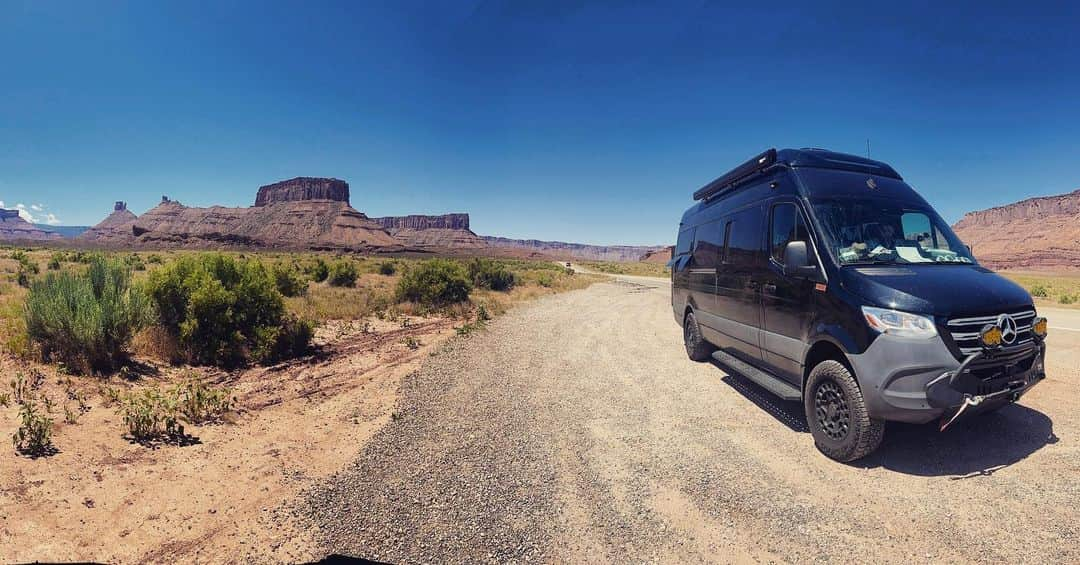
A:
[0,277,1080,563]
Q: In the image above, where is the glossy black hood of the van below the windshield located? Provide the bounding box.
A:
[840,265,1032,317]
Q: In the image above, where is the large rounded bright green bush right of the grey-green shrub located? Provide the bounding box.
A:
[147,254,310,366]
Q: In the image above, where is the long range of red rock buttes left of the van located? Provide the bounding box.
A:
[79,177,666,260]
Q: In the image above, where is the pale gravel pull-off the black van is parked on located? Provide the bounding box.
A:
[300,278,1080,563]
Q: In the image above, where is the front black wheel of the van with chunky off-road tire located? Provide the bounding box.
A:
[802,361,885,462]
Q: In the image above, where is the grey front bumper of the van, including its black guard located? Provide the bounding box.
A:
[848,335,1045,423]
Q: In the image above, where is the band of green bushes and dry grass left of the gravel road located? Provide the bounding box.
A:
[0,247,604,457]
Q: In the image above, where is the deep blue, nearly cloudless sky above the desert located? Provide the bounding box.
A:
[0,0,1080,244]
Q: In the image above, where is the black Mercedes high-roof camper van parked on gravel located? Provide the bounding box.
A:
[670,149,1047,461]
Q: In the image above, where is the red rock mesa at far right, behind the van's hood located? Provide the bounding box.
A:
[953,190,1080,269]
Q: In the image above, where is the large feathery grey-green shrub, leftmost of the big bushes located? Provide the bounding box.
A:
[25,255,151,371]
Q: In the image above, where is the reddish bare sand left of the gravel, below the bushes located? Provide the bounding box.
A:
[0,319,454,563]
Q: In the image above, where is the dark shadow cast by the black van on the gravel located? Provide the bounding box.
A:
[714,363,1058,480]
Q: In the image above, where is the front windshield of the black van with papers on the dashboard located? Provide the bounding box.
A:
[812,199,975,265]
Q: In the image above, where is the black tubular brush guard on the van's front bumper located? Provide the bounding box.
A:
[926,340,1047,431]
